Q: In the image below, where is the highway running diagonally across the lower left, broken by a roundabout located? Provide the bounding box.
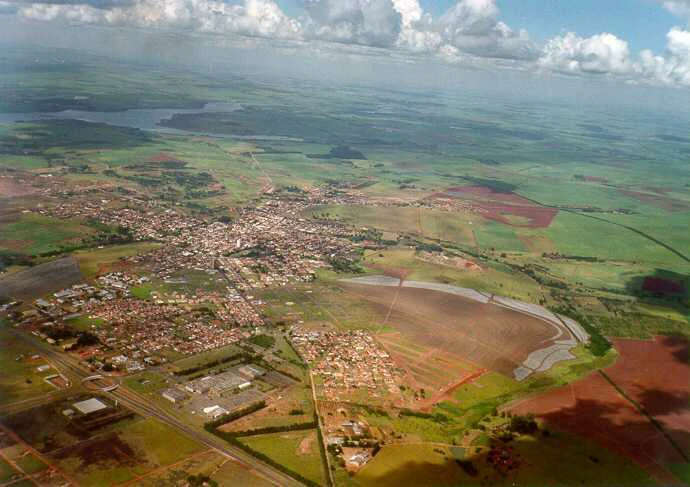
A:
[8,328,302,486]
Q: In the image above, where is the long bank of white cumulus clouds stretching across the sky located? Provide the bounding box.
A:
[0,0,690,87]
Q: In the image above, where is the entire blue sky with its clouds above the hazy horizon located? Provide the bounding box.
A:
[0,0,690,90]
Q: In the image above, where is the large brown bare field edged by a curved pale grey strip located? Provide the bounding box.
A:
[342,282,564,377]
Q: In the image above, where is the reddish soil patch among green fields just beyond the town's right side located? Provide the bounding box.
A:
[437,186,558,228]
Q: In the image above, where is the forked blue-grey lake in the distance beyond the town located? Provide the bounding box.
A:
[0,102,302,142]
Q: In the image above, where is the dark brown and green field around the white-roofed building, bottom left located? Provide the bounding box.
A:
[2,397,202,485]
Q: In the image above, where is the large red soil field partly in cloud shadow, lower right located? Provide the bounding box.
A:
[508,337,690,483]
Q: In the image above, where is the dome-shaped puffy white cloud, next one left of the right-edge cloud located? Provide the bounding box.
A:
[537,32,634,74]
